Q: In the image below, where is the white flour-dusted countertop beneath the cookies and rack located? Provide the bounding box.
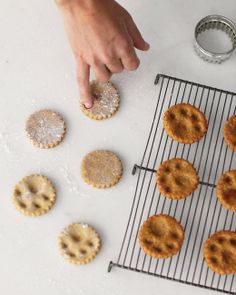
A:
[0,0,236,295]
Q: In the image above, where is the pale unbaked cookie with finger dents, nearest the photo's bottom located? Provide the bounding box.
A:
[59,223,101,264]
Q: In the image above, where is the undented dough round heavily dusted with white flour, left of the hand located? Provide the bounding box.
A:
[25,109,66,149]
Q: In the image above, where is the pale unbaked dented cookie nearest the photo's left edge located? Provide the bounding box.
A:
[12,174,56,216]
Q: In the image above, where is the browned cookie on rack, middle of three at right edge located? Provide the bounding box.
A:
[216,170,236,211]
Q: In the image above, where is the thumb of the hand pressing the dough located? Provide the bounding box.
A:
[126,17,150,51]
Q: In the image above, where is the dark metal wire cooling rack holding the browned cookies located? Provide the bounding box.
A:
[108,74,236,294]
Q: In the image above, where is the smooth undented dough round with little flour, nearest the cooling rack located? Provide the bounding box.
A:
[80,150,123,188]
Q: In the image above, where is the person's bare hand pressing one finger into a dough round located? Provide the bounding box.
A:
[55,0,149,108]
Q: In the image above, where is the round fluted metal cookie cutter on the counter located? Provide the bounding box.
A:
[194,15,236,63]
